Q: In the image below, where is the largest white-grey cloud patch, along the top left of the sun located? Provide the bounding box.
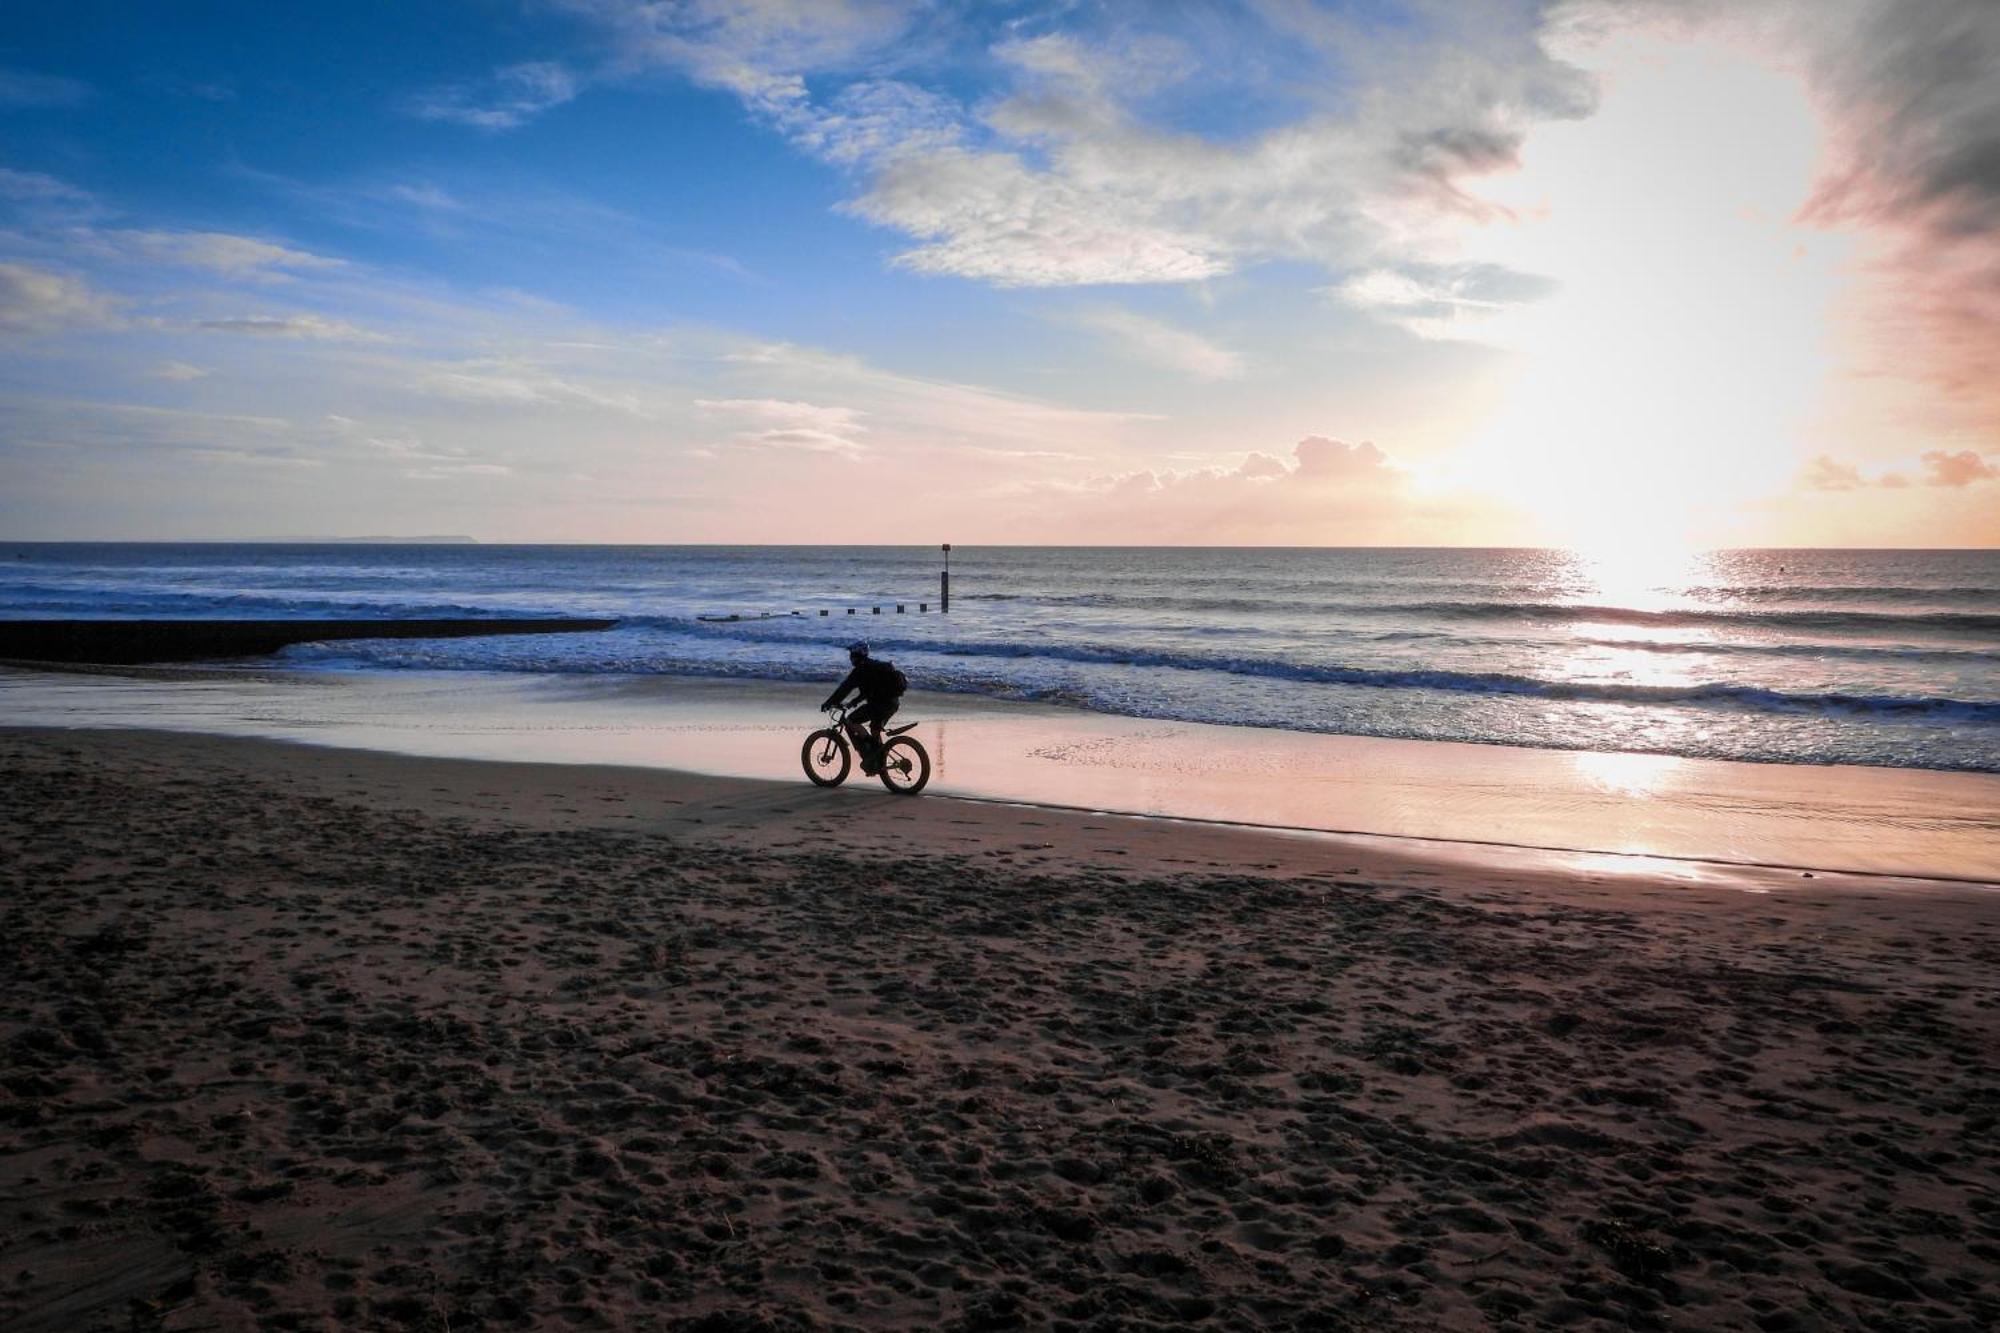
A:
[570,0,1588,286]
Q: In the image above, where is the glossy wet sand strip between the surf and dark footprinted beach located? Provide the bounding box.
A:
[0,667,2000,885]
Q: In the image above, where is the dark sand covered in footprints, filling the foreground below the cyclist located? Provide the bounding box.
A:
[0,731,2000,1329]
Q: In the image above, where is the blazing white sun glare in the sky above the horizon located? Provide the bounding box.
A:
[1468,29,1840,552]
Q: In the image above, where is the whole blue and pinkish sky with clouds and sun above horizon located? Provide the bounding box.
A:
[0,0,2000,544]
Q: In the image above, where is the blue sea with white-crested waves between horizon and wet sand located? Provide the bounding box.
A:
[0,542,2000,773]
